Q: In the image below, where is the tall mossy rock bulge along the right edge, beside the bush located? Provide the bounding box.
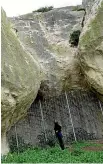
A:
[79,0,103,96]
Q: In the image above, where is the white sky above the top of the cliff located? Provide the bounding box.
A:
[1,0,82,17]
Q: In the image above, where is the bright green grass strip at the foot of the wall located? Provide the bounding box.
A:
[2,142,103,163]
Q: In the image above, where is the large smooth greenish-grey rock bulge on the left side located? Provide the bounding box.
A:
[1,9,41,154]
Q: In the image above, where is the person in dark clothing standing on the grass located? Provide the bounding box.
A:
[54,121,64,150]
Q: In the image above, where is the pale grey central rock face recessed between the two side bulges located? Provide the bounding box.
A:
[11,7,84,95]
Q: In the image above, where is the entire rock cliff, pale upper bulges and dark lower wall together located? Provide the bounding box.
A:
[2,0,103,154]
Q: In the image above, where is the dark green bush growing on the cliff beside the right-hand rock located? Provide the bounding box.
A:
[69,30,81,46]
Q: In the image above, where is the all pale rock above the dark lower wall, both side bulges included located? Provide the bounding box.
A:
[1,0,103,154]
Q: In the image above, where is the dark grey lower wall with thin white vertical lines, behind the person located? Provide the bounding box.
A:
[8,90,103,149]
